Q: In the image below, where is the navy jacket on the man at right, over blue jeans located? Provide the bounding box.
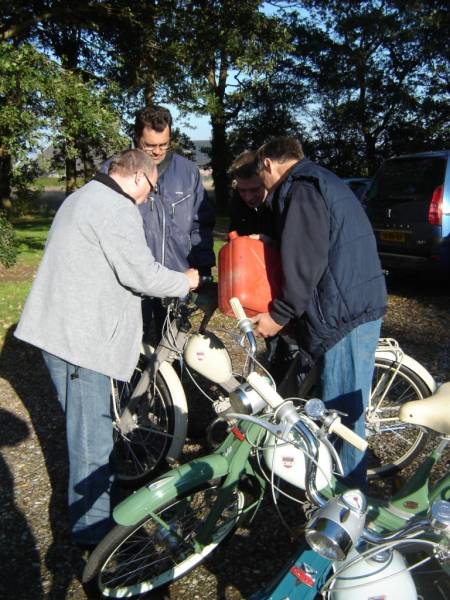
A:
[269,158,387,360]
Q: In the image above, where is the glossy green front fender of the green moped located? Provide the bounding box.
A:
[113,454,228,525]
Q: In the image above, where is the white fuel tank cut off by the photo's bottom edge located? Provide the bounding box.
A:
[327,549,417,600]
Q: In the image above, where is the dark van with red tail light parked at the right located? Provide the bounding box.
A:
[364,150,450,277]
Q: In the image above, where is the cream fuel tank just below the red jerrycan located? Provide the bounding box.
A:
[183,332,233,385]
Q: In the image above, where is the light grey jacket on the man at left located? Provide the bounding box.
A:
[15,178,189,380]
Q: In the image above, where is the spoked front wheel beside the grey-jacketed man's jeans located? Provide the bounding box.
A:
[111,356,175,487]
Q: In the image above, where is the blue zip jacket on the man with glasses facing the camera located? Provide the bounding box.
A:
[101,153,215,275]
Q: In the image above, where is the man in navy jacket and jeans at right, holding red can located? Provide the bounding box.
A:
[253,137,386,487]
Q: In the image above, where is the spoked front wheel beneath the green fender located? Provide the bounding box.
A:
[83,481,246,598]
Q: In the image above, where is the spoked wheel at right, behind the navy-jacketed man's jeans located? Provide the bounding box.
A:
[366,357,431,479]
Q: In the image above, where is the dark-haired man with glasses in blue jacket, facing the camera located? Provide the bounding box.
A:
[102,105,215,338]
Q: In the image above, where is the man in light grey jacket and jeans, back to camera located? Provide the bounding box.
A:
[15,150,198,546]
